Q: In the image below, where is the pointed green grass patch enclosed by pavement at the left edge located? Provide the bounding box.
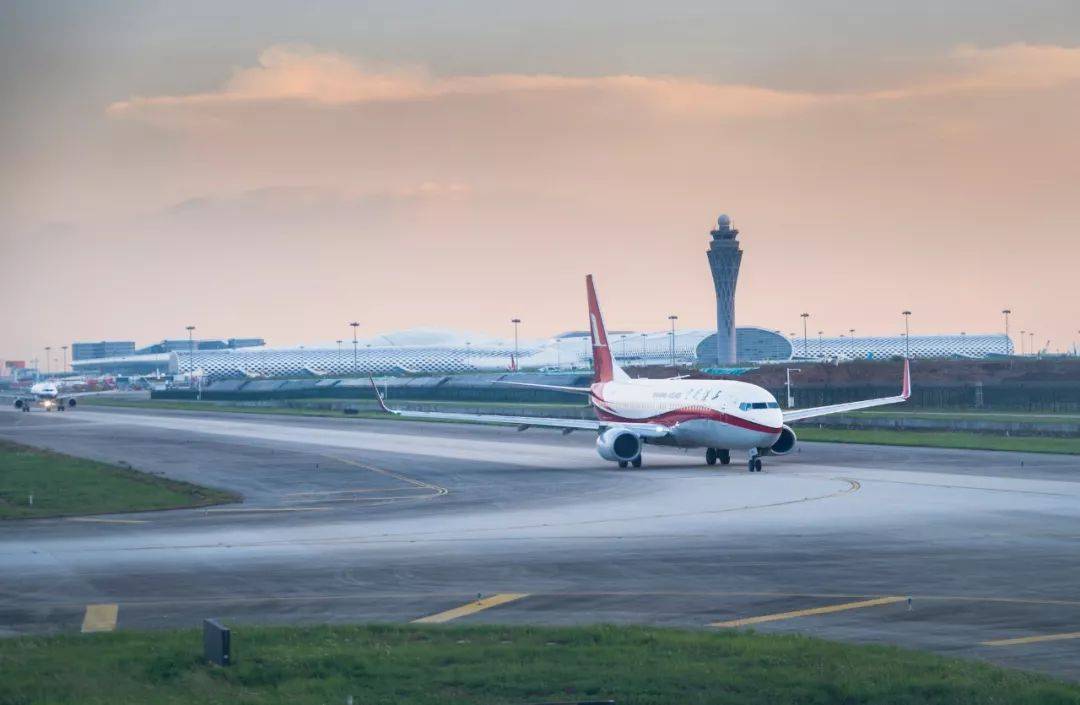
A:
[0,440,239,520]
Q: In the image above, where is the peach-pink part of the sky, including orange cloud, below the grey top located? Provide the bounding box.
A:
[0,37,1080,358]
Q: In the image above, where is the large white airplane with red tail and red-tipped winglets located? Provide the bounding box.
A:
[372,274,912,473]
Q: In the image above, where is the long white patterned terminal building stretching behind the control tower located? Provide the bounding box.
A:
[72,327,1013,379]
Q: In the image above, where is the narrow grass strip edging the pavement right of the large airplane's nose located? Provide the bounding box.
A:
[795,425,1080,455]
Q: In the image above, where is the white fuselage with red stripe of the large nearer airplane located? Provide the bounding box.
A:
[590,379,784,449]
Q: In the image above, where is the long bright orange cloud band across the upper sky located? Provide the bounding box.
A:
[108,43,1080,121]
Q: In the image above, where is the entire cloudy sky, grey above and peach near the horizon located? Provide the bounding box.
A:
[0,0,1080,360]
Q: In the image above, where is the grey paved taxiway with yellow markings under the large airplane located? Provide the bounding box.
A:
[0,408,1080,679]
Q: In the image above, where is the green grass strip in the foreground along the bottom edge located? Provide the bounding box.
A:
[0,625,1080,705]
